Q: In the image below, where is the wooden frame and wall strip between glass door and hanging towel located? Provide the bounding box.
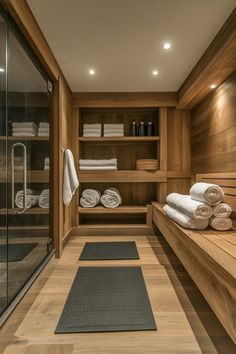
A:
[4,0,72,256]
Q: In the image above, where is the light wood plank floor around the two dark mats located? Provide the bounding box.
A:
[0,231,235,354]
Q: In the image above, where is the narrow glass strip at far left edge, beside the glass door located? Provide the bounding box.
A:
[0,9,7,314]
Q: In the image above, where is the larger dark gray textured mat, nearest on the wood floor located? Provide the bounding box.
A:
[55,267,156,333]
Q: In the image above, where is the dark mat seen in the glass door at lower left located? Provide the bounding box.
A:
[0,243,37,262]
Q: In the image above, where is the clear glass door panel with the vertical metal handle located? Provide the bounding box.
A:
[8,23,50,301]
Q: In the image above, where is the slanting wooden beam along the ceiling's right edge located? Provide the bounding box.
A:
[177,8,236,109]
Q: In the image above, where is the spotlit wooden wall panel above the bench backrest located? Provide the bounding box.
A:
[191,71,236,174]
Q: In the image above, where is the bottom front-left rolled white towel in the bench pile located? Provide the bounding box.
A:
[163,204,209,230]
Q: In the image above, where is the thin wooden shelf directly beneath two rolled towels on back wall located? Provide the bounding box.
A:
[78,205,147,214]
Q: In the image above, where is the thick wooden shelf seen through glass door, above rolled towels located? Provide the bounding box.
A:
[0,170,49,183]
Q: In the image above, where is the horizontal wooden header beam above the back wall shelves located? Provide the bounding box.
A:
[73,92,177,108]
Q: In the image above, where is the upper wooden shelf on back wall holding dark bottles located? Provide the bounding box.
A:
[78,136,160,143]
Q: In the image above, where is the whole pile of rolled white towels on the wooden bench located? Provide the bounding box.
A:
[163,182,232,231]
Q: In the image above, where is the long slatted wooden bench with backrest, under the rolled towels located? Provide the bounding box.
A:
[153,174,236,344]
